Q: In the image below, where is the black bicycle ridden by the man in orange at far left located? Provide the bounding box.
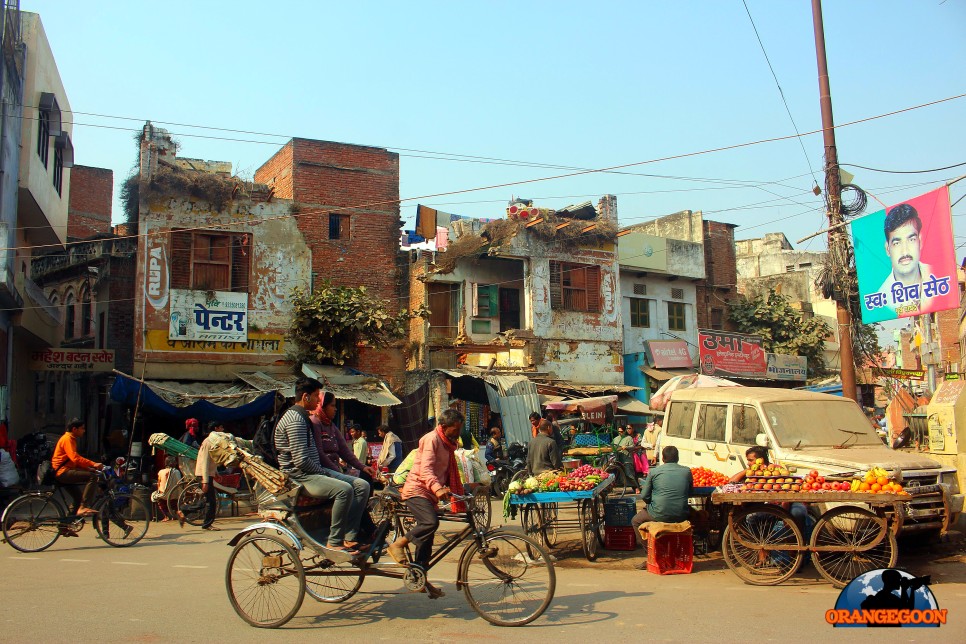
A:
[0,468,151,552]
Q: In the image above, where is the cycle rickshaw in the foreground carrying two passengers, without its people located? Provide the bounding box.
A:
[225,488,556,628]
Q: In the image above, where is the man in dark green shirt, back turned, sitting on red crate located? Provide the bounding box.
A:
[631,445,694,568]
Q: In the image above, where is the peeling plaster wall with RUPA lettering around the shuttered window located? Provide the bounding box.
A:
[134,198,311,380]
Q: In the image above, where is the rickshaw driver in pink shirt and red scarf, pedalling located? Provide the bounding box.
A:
[388,409,464,599]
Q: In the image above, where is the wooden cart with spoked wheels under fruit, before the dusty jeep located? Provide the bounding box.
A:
[711,492,932,588]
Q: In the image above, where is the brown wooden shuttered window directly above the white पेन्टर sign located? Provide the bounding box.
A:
[171,230,252,292]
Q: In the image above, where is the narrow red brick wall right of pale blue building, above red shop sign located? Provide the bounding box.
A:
[695,219,738,331]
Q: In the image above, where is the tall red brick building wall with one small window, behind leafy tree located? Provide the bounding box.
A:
[255,139,405,384]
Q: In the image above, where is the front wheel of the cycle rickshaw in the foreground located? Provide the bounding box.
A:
[458,532,557,626]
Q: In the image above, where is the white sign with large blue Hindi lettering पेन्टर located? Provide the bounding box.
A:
[168,289,248,342]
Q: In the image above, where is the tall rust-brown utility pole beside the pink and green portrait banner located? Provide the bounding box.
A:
[812,0,858,401]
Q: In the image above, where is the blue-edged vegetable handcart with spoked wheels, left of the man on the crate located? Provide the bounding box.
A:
[510,475,615,561]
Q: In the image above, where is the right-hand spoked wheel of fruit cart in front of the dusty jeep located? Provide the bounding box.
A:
[810,506,899,588]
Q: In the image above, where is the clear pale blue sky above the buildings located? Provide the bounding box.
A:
[21,0,966,252]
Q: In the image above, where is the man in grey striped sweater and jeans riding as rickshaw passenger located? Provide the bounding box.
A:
[275,378,361,556]
